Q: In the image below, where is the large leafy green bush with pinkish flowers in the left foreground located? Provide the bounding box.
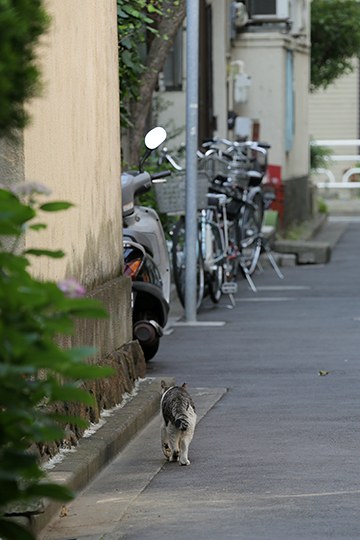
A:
[0,184,112,540]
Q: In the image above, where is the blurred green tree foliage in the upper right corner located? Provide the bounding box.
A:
[311,0,360,91]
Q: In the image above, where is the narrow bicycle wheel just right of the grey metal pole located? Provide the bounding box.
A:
[204,220,225,304]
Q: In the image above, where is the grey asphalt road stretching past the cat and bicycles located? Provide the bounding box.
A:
[40,217,360,540]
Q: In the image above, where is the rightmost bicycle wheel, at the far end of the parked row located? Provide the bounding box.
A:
[237,192,264,275]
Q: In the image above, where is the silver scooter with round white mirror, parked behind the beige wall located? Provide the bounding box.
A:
[121,127,171,361]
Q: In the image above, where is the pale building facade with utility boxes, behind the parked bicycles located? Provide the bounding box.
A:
[160,0,312,227]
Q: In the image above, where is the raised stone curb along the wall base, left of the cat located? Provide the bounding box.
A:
[28,377,174,534]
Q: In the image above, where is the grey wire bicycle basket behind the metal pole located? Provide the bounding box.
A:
[154,171,209,214]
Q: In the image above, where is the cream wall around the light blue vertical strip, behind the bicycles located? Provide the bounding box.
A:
[232,31,312,227]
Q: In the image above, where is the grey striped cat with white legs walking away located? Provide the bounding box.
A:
[160,381,196,465]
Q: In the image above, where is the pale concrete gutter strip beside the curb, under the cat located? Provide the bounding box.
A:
[39,388,226,540]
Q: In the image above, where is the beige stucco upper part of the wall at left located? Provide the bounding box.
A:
[24,0,122,288]
